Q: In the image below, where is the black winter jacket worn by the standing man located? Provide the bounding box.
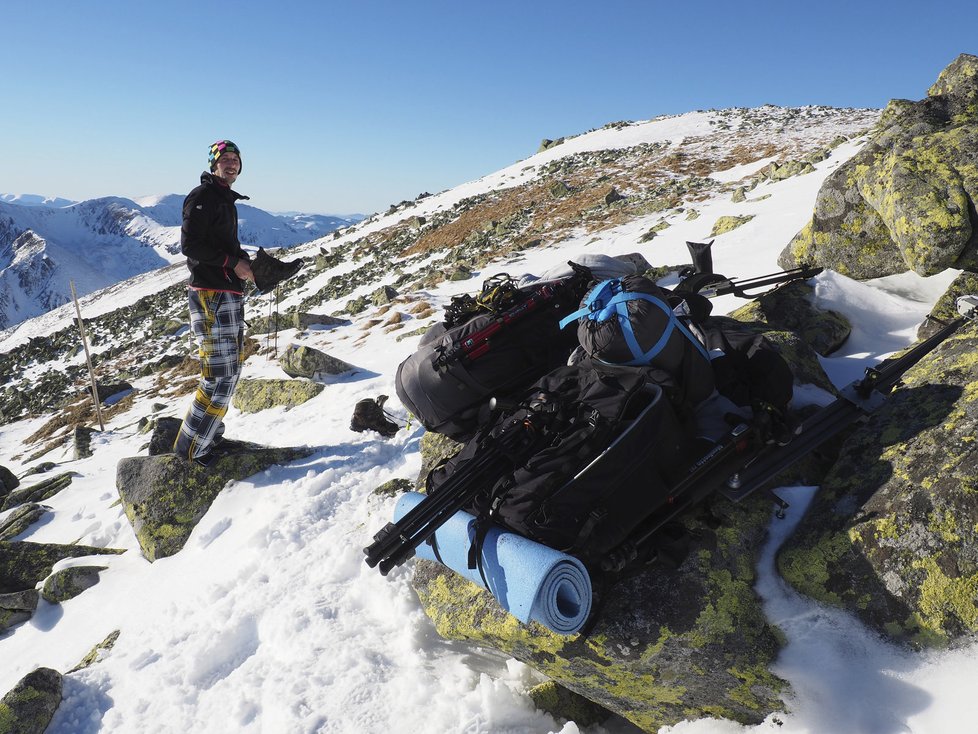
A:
[180,172,250,293]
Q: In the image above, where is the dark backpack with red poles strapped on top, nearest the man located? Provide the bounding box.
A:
[395,266,591,441]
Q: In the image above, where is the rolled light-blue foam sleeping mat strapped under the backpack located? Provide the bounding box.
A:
[394,492,592,635]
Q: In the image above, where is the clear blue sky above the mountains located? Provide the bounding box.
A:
[0,0,978,214]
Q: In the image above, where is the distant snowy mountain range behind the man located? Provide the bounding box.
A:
[0,194,363,329]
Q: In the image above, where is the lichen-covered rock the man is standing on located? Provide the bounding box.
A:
[116,446,312,561]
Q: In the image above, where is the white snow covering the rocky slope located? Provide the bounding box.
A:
[0,106,978,734]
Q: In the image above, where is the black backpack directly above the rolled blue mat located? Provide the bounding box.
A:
[427,360,692,567]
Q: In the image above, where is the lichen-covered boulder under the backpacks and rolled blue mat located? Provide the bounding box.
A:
[414,497,787,732]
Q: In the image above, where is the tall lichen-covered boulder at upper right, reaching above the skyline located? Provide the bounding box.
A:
[778,54,978,278]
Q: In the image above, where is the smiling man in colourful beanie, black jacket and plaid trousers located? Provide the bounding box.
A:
[173,140,255,467]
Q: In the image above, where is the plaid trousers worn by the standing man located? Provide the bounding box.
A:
[173,290,244,459]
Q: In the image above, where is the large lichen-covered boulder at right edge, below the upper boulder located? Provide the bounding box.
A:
[778,326,978,645]
